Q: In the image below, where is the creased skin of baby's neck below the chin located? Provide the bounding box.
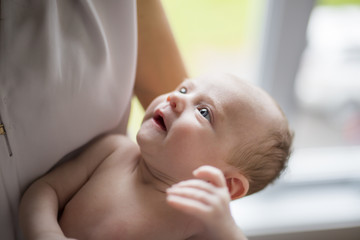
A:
[138,157,178,193]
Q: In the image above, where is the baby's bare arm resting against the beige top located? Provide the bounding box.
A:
[20,136,124,240]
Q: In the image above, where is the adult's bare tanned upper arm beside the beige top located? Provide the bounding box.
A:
[135,0,187,108]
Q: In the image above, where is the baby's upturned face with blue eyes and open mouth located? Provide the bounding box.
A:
[137,76,277,180]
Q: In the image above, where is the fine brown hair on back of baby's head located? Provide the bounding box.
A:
[228,104,293,195]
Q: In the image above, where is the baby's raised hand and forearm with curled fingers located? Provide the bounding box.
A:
[167,166,247,240]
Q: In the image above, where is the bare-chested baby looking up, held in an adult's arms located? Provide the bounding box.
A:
[20,75,292,240]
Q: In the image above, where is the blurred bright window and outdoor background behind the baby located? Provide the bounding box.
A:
[129,0,360,240]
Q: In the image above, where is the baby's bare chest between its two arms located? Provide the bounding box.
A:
[60,164,194,240]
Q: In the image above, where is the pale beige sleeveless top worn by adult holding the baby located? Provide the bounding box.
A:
[0,0,137,240]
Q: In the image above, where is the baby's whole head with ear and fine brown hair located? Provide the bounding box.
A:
[137,75,292,199]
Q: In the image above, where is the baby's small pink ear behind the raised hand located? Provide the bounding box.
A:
[225,172,249,200]
